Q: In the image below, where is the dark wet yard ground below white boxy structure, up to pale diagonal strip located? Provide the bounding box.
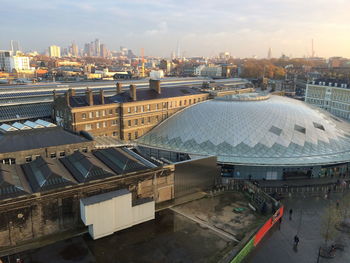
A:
[2,209,233,263]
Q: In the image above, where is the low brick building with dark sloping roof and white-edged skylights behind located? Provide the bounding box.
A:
[0,120,94,164]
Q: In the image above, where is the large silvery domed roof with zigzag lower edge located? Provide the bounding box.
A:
[138,95,350,165]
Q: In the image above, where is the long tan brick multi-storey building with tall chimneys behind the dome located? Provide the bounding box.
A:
[53,80,209,141]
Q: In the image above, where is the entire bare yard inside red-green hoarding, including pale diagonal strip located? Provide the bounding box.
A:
[4,192,266,263]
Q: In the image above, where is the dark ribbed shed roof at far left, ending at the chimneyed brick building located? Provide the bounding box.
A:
[0,103,52,122]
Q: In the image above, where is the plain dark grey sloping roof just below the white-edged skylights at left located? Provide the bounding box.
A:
[0,127,88,153]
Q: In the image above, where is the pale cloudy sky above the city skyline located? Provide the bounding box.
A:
[0,0,350,58]
